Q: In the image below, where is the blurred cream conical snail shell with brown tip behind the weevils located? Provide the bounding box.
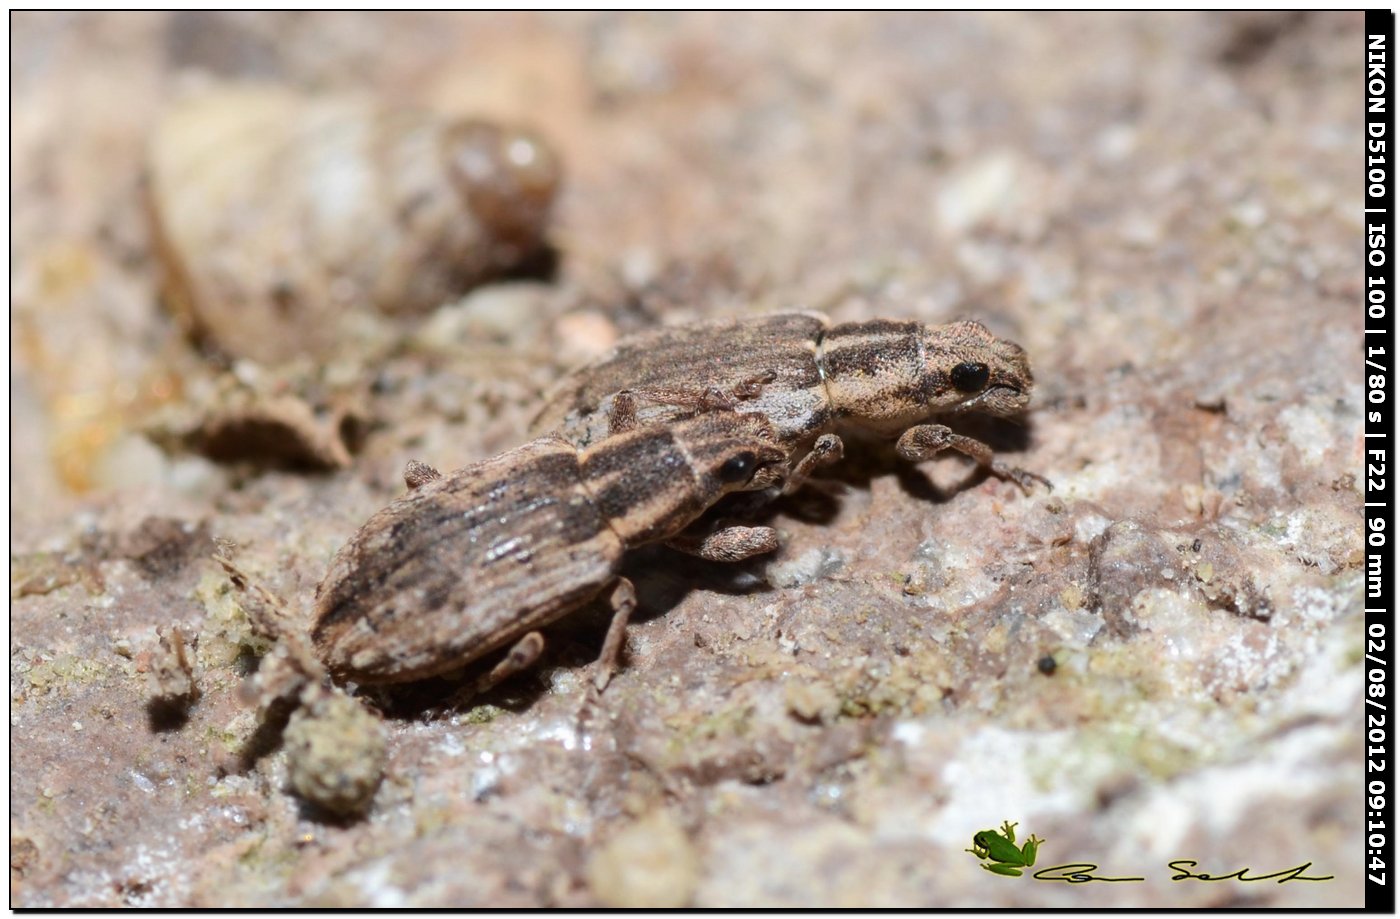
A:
[147,87,559,361]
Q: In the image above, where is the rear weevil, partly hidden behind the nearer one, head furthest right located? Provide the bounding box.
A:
[532,312,1049,509]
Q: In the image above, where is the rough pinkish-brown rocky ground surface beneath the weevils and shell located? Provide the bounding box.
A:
[10,13,1365,908]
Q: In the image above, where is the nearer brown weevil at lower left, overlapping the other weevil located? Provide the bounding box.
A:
[311,410,787,689]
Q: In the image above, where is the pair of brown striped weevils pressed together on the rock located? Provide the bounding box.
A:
[224,312,1049,714]
